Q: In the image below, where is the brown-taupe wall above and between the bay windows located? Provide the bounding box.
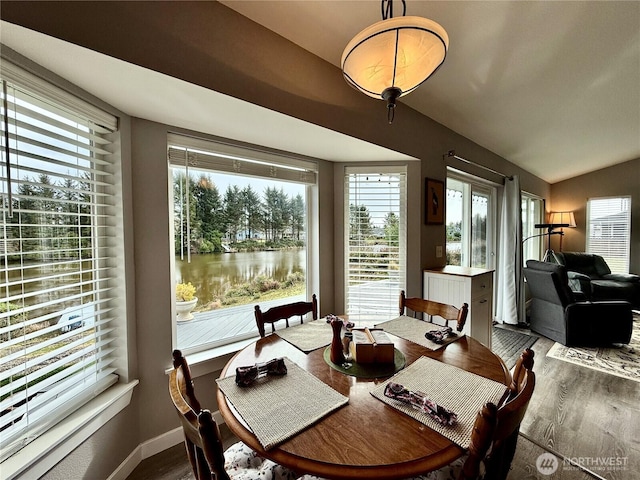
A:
[0,0,549,478]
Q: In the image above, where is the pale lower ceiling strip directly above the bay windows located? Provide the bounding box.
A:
[0,21,416,167]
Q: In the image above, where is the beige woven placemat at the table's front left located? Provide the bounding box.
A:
[216,358,349,450]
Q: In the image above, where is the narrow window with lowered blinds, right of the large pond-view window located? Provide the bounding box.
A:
[344,167,406,321]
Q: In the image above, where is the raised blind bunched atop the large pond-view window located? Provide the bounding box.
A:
[167,134,317,185]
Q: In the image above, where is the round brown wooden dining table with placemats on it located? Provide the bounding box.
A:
[217,332,511,480]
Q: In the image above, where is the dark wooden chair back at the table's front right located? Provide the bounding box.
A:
[458,349,536,480]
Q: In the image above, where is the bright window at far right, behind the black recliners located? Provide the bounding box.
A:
[587,197,631,273]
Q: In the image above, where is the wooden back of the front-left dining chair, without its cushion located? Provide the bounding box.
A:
[169,350,230,480]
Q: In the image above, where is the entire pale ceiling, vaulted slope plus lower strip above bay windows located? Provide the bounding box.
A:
[0,0,640,183]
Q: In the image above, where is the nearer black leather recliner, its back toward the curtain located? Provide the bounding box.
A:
[524,260,633,347]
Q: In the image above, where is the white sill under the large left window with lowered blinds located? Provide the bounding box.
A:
[2,380,138,480]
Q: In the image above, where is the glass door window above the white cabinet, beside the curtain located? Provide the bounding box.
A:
[446,171,495,268]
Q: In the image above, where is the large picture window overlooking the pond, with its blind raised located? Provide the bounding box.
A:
[168,134,316,353]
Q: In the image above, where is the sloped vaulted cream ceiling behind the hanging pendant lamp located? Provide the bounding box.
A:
[221,0,640,183]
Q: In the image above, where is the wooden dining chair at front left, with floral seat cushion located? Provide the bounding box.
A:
[169,350,296,480]
